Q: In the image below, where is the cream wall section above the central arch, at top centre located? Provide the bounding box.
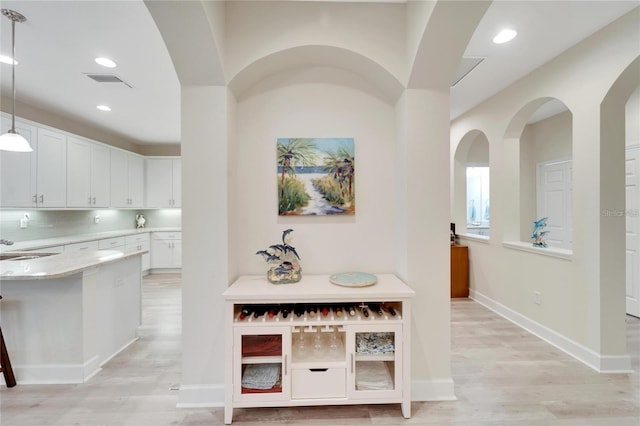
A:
[225,1,406,83]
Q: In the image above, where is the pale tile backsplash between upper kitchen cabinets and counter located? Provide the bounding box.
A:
[0,209,182,242]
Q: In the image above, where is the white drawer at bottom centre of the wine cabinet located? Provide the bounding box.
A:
[291,368,347,398]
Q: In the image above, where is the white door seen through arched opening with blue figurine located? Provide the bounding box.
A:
[536,161,573,249]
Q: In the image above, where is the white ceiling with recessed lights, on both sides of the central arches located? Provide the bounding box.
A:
[0,0,640,144]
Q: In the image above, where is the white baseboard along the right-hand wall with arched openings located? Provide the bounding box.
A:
[469,289,632,373]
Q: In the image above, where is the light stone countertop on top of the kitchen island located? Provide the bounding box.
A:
[0,250,148,281]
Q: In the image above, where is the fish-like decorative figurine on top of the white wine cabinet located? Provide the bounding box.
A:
[256,229,302,284]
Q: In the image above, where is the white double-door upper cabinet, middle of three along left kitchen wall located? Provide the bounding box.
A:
[67,136,110,208]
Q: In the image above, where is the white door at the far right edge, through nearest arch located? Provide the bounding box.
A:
[625,148,640,317]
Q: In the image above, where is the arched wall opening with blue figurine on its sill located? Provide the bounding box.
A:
[519,99,573,249]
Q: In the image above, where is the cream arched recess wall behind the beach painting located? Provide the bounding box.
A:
[231,68,395,274]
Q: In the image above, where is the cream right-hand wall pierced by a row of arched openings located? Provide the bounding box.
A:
[451,9,640,370]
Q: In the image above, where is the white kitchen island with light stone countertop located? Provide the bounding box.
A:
[0,250,146,384]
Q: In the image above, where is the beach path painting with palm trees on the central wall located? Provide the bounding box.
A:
[277,138,356,216]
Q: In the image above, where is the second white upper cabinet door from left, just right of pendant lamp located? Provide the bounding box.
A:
[37,129,67,207]
